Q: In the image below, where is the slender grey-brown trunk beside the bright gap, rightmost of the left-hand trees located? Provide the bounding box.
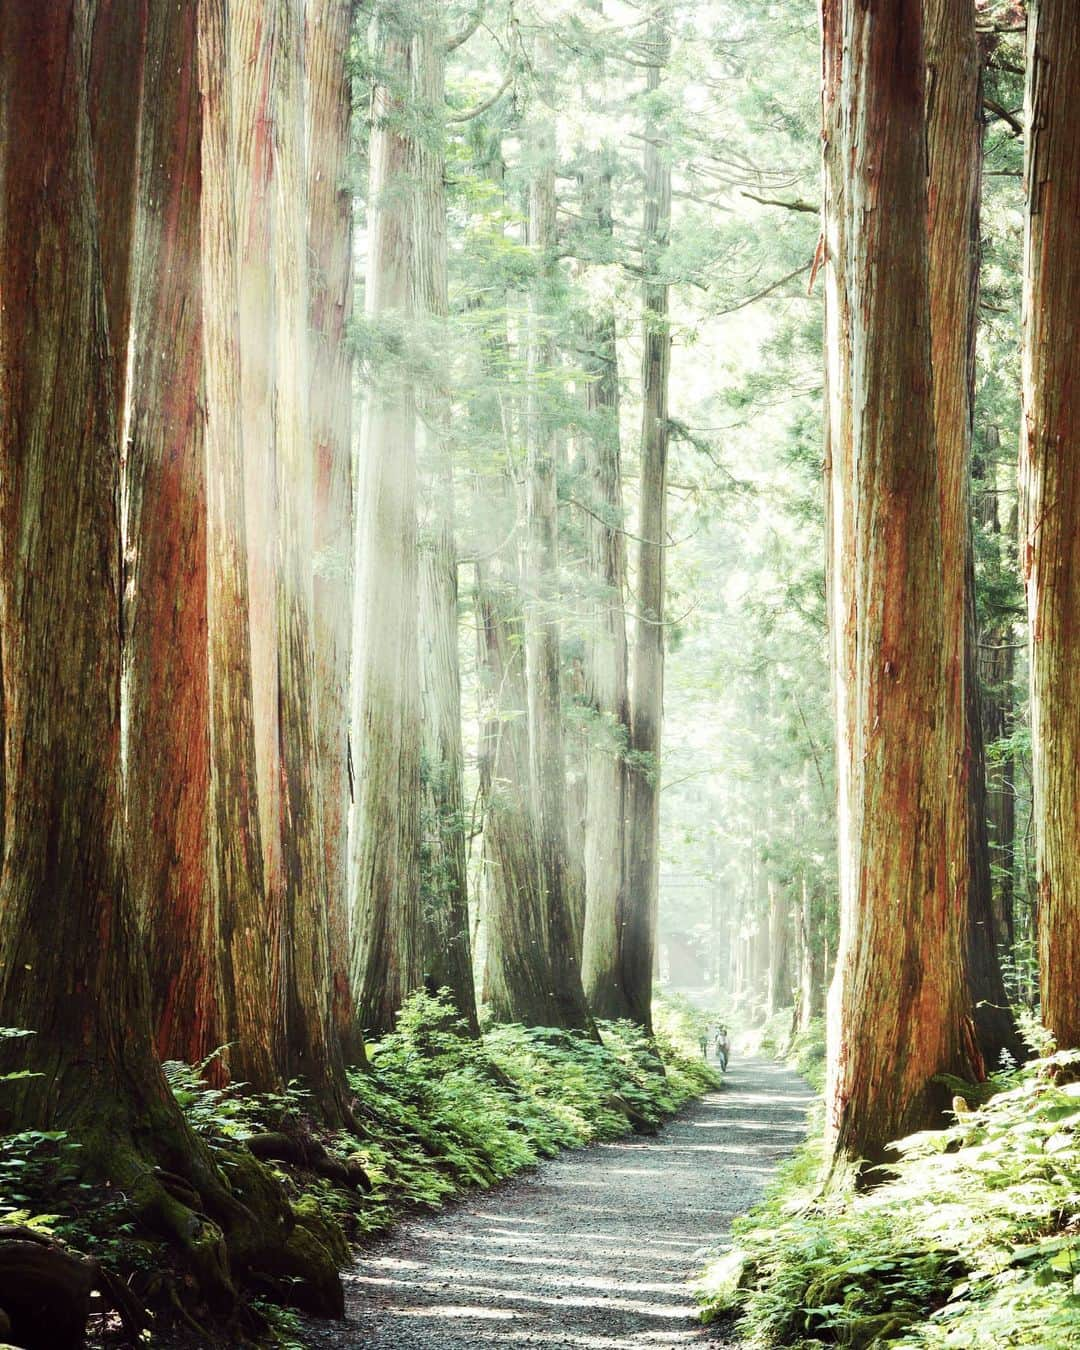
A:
[620,15,671,1031]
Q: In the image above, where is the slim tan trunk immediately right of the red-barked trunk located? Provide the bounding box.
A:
[198,0,281,1091]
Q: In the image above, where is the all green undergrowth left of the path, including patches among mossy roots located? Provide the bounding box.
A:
[0,992,718,1345]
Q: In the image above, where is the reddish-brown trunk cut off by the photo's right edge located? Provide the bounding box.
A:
[1021,0,1080,1046]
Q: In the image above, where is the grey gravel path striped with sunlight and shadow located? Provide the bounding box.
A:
[295,1060,811,1350]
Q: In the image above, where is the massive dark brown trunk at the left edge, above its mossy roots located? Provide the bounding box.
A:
[0,0,166,1128]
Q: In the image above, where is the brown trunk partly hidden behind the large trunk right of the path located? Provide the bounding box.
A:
[923,0,1021,1064]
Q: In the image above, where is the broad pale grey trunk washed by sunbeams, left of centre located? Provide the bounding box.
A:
[352,21,423,1033]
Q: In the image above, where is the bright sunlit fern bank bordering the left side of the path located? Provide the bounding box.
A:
[337,994,717,1233]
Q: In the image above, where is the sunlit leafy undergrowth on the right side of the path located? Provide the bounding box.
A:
[699,1052,1080,1350]
